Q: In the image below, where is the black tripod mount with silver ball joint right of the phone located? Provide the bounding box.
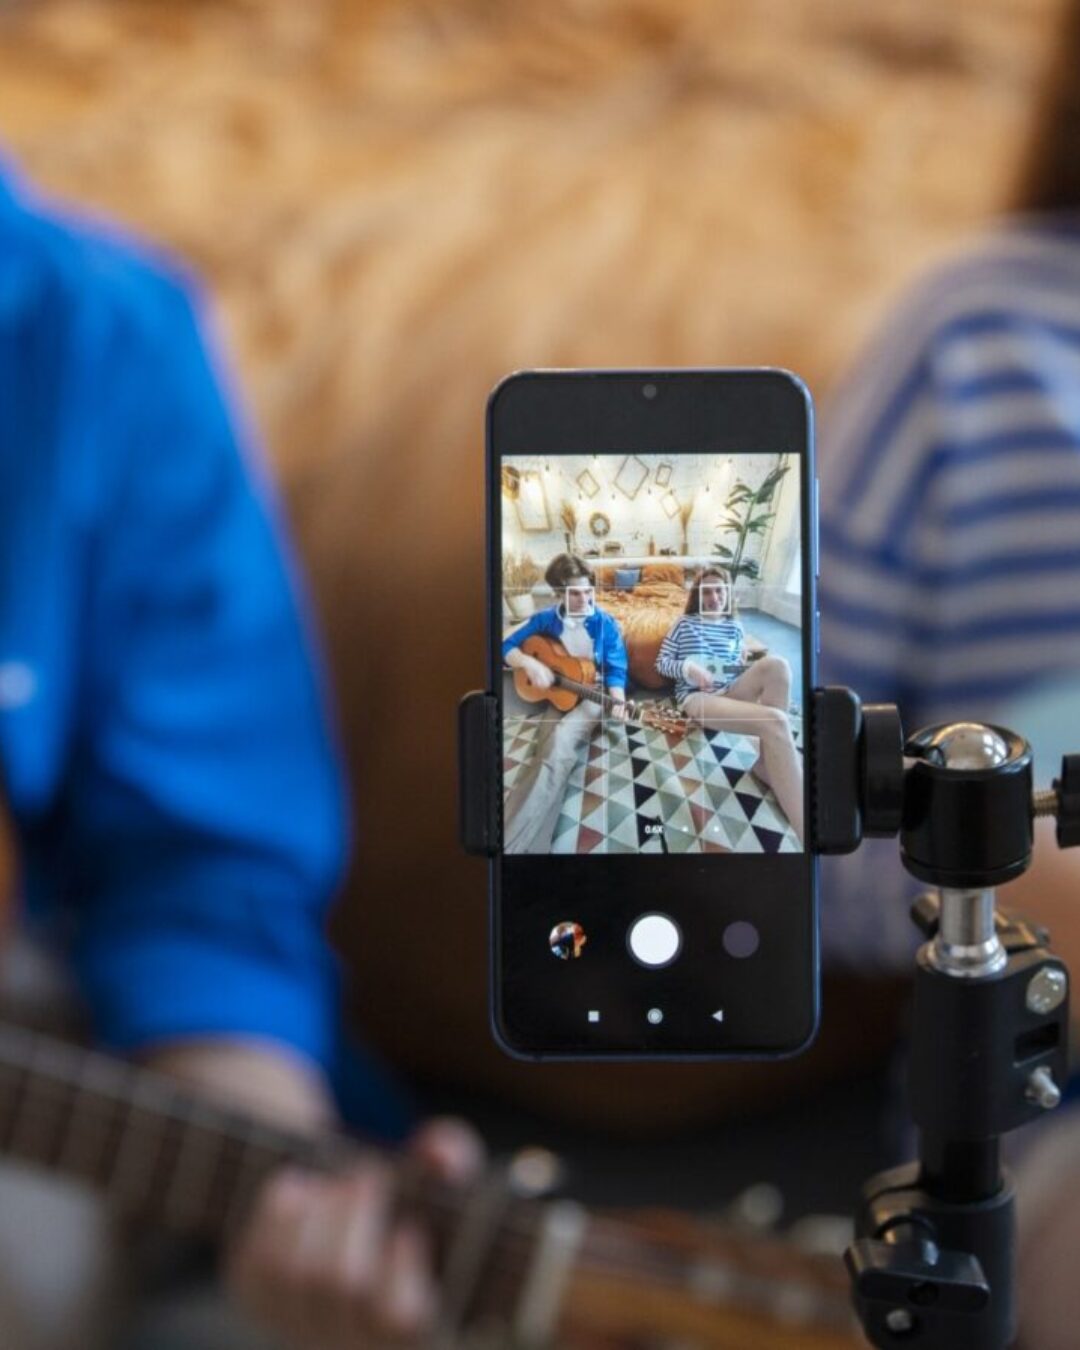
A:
[813,689,1080,1350]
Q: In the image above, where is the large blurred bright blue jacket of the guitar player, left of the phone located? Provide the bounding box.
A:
[0,157,410,1128]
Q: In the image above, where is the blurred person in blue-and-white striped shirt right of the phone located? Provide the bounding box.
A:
[821,10,1080,1350]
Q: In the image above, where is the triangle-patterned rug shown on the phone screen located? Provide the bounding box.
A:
[502,713,802,853]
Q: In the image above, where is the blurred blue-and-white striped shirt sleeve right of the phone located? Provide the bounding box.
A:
[821,234,1080,967]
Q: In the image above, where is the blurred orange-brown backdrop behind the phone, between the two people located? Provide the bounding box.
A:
[0,0,1060,1127]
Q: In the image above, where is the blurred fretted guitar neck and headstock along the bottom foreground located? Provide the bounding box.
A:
[0,1023,856,1350]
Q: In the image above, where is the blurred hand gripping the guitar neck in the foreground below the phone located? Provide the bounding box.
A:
[227,1119,483,1350]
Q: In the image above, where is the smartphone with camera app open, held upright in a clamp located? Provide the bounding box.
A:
[487,370,819,1060]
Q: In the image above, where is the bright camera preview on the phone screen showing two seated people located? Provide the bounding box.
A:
[501,454,803,853]
